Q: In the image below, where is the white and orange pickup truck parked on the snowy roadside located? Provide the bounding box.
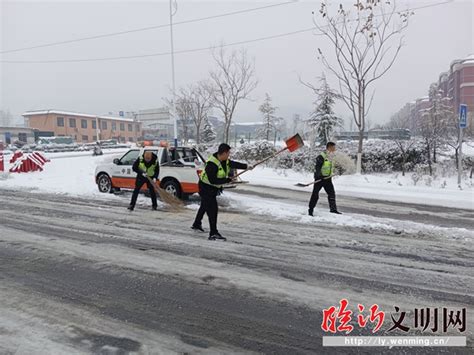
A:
[95,146,205,198]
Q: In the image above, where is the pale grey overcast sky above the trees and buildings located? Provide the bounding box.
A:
[0,0,474,128]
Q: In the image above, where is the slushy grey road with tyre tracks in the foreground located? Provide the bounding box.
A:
[0,186,474,354]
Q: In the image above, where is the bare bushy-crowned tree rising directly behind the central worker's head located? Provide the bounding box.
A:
[210,45,257,143]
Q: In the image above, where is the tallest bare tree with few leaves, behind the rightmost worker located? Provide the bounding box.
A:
[314,0,412,173]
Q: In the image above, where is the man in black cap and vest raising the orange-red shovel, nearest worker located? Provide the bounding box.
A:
[191,143,253,240]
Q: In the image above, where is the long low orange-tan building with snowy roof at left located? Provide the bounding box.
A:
[22,110,142,143]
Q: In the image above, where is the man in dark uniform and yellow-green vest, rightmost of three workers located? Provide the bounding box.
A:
[308,142,342,216]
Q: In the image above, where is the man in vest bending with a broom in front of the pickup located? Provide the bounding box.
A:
[128,150,160,211]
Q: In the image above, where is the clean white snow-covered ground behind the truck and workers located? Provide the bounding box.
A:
[0,149,474,209]
